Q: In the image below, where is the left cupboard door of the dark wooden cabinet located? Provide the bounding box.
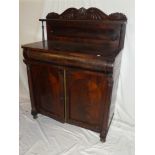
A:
[30,64,64,122]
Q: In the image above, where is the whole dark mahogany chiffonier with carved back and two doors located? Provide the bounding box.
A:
[22,8,127,142]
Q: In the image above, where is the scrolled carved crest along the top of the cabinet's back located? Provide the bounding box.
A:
[46,8,127,21]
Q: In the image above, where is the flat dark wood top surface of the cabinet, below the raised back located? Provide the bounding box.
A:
[22,40,120,61]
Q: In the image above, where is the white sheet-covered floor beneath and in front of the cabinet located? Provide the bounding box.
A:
[19,103,134,155]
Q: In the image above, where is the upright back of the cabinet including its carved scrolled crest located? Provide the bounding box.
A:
[46,8,127,51]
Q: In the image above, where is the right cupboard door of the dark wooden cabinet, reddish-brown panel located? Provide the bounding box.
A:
[66,69,107,132]
